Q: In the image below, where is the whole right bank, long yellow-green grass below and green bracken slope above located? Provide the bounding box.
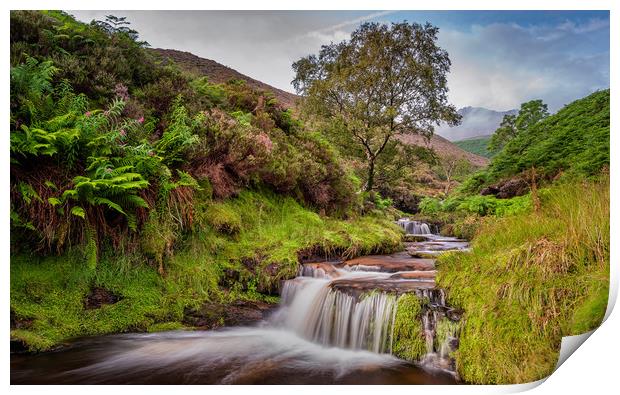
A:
[420,90,610,384]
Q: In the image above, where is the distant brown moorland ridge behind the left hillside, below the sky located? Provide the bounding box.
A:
[149,48,298,108]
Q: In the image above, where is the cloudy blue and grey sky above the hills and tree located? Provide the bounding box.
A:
[69,11,610,112]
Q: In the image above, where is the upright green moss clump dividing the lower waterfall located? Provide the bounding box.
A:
[392,294,426,361]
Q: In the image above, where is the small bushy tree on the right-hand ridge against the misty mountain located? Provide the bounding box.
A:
[487,100,549,151]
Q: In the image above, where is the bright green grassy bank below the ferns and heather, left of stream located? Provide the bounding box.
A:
[11,191,401,351]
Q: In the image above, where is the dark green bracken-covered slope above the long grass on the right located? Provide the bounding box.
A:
[460,90,609,193]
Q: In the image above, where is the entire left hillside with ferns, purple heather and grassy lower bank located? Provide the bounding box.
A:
[10,11,401,351]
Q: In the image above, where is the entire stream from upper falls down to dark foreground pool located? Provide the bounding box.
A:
[11,219,468,384]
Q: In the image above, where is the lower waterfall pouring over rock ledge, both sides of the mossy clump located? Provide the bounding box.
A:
[271,258,457,371]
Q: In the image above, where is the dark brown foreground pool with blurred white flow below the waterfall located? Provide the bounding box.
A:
[11,326,456,384]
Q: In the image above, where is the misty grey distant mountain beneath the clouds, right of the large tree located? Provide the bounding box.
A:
[436,107,518,141]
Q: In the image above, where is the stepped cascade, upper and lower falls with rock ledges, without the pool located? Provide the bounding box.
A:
[271,232,469,374]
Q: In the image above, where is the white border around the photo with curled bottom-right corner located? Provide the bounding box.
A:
[0,0,620,394]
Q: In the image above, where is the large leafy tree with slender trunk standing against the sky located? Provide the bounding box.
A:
[293,22,460,191]
